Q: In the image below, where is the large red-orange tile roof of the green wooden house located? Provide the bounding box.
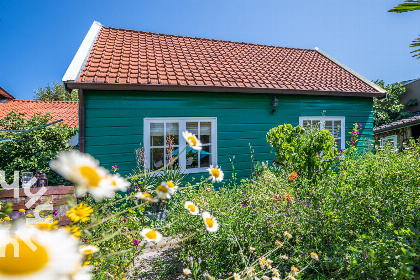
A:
[76,27,379,93]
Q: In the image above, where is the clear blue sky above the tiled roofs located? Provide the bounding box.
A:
[0,0,420,99]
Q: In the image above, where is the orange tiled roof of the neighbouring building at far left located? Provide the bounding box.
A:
[0,99,79,127]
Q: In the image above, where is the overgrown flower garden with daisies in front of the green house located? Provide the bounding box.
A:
[0,121,420,280]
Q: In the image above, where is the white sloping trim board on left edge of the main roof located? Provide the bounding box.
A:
[62,21,103,83]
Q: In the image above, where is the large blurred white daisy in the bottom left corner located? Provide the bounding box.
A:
[0,224,82,280]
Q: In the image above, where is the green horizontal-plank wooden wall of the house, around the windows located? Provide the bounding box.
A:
[84,90,373,178]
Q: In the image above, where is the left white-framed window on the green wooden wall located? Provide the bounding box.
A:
[144,118,217,173]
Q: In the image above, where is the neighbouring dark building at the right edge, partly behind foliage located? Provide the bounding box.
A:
[374,79,420,149]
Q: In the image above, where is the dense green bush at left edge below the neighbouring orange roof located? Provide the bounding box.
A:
[0,111,78,185]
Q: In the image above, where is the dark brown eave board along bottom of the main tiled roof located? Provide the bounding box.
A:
[66,82,382,97]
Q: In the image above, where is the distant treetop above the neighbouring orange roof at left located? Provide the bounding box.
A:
[34,82,79,101]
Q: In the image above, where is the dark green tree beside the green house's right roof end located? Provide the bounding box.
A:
[373,80,411,126]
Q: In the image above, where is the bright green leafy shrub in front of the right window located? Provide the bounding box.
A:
[266,124,337,178]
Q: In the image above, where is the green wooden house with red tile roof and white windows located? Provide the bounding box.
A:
[63,22,385,177]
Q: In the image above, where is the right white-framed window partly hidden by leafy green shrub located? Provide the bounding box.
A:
[299,117,346,150]
